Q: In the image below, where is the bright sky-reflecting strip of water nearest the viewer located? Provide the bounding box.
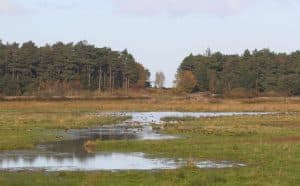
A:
[0,153,179,171]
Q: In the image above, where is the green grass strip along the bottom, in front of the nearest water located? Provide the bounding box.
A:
[0,167,299,186]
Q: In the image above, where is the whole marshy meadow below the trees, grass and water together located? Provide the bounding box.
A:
[0,98,300,185]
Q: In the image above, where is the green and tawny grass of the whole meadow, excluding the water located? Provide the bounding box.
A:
[0,98,300,186]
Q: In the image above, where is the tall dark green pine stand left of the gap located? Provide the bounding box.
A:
[0,40,150,95]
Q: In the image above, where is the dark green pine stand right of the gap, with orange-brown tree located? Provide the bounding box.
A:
[176,49,300,96]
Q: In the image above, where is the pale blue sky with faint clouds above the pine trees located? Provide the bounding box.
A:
[0,0,300,87]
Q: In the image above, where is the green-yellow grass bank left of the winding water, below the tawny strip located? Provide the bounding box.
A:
[0,112,128,150]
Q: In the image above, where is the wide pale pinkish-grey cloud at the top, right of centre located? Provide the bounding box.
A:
[112,0,300,16]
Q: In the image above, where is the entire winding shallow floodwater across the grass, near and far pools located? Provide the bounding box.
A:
[0,112,272,171]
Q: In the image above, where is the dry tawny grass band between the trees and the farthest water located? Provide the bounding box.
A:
[0,98,300,112]
